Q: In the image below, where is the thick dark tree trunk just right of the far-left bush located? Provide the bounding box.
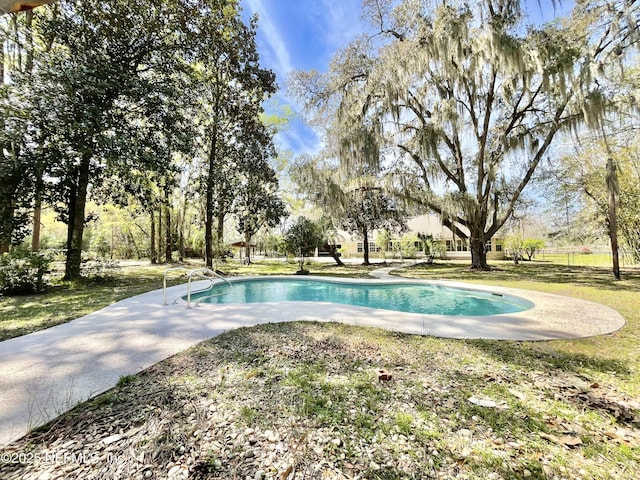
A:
[64,154,91,280]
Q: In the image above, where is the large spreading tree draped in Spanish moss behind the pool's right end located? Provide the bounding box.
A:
[293,0,640,269]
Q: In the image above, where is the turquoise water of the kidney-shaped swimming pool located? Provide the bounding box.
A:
[191,278,533,315]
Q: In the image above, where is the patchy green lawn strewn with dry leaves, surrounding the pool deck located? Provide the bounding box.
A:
[0,256,640,480]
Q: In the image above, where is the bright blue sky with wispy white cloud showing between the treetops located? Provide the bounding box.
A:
[241,0,573,155]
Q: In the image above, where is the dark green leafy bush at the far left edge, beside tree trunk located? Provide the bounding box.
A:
[0,251,53,295]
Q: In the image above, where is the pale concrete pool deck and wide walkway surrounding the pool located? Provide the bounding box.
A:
[0,269,625,447]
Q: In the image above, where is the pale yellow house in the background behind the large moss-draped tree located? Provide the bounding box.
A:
[330,214,505,260]
